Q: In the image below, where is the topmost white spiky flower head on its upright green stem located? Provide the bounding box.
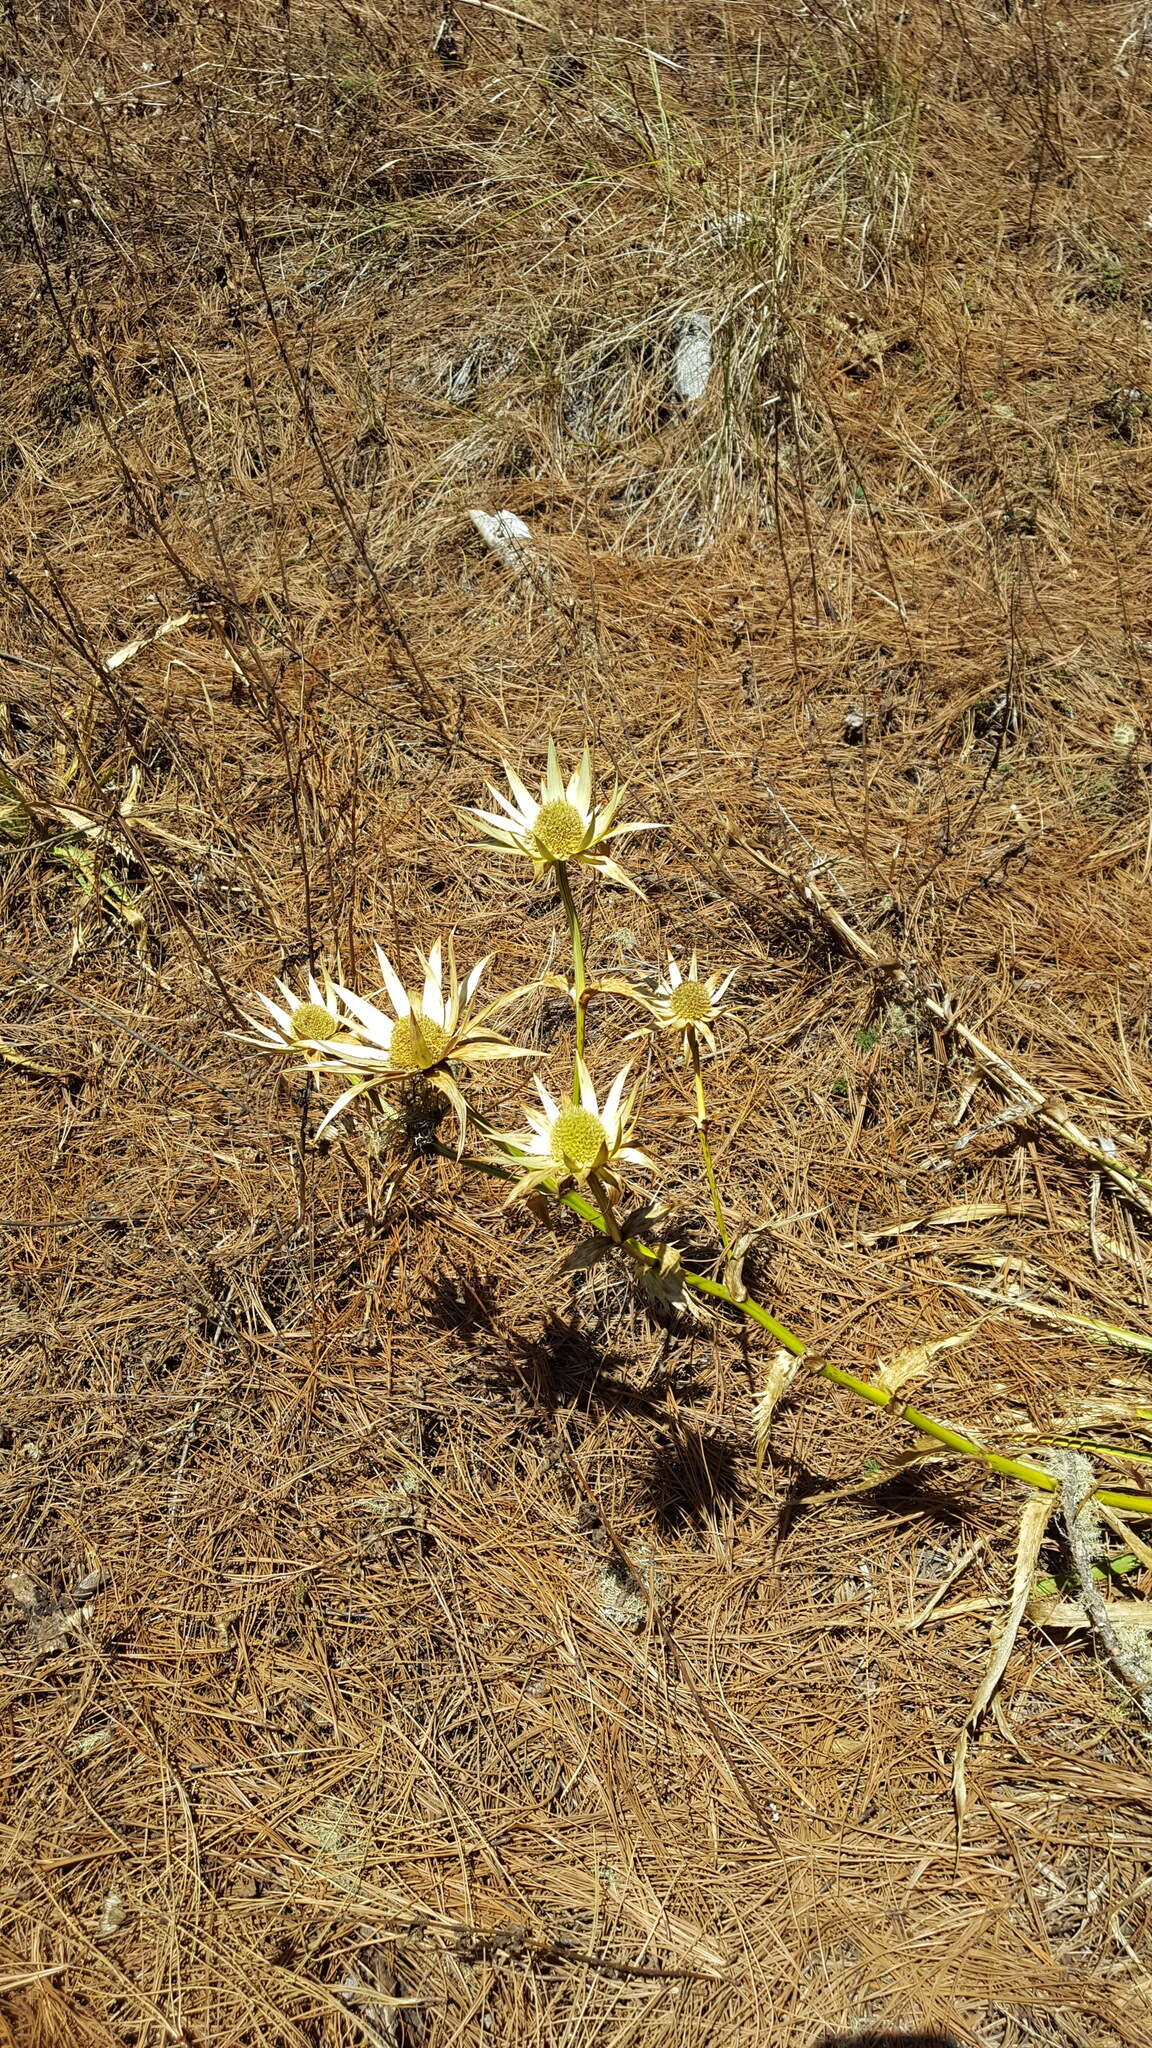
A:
[463,739,662,895]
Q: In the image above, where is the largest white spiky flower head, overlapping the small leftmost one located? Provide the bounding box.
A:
[309,936,537,1149]
